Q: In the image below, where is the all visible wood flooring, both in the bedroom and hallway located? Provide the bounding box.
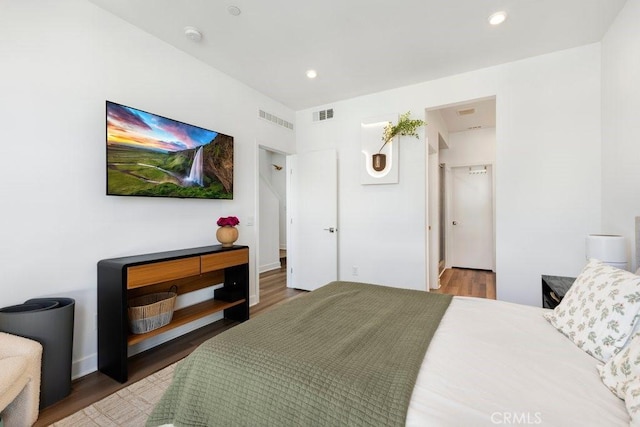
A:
[35,263,484,426]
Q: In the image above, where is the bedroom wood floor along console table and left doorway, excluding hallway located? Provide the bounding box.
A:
[35,260,305,427]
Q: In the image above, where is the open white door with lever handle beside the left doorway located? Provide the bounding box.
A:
[287,150,338,291]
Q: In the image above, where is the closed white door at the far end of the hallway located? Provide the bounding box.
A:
[450,166,493,270]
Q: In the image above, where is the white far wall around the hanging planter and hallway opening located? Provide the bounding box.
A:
[296,44,601,306]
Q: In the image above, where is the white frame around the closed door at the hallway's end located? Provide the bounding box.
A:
[445,162,496,272]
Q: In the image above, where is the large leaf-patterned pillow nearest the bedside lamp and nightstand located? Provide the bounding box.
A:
[544,259,640,362]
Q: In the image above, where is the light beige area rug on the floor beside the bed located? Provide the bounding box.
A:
[52,363,176,427]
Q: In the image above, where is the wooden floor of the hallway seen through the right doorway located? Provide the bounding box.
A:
[432,268,496,299]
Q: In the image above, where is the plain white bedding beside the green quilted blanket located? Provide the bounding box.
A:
[407,297,629,427]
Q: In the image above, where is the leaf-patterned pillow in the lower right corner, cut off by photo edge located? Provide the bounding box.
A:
[598,334,640,425]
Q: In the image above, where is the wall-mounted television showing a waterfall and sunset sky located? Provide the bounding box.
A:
[106,101,233,199]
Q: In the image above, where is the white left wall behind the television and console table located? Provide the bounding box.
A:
[0,0,294,376]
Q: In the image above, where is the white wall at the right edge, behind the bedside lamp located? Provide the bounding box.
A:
[590,0,640,271]
